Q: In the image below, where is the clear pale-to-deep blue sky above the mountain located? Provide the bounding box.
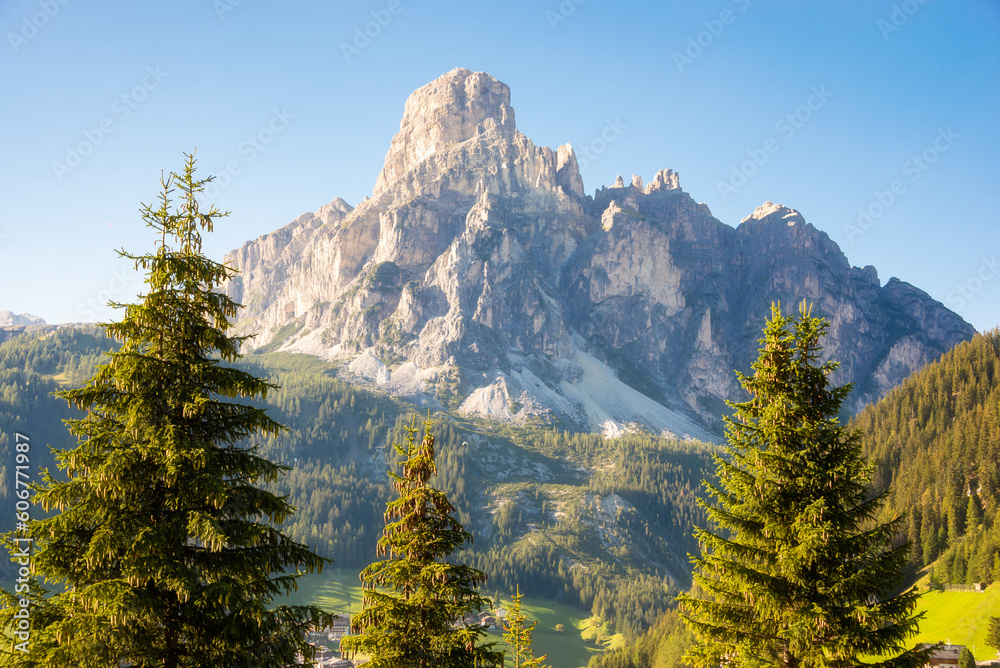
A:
[0,0,1000,330]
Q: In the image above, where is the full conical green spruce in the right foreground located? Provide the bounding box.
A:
[679,303,927,668]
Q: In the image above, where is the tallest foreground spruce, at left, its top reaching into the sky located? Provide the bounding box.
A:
[0,155,331,668]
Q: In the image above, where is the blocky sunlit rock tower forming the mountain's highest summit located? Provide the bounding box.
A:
[373,68,515,199]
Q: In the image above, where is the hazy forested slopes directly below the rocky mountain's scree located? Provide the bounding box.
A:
[0,329,715,636]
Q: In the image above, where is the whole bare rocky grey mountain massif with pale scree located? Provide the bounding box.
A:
[226,69,974,437]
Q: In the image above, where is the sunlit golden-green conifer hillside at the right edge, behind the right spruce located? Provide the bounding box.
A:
[852,329,1000,584]
